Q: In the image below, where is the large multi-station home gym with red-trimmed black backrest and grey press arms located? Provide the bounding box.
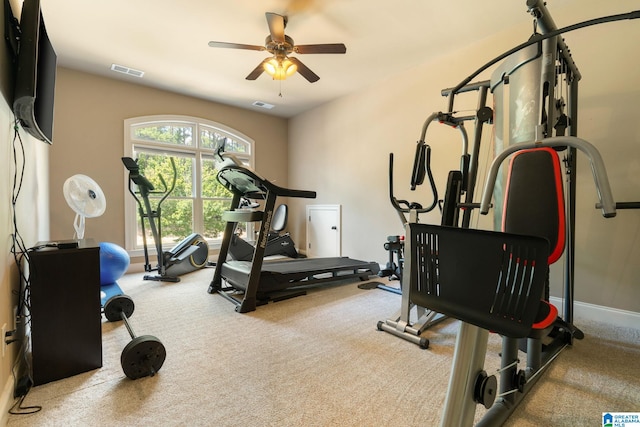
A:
[404,0,640,427]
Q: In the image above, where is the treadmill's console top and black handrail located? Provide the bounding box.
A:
[217,164,316,199]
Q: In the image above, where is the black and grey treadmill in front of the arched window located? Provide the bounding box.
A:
[208,153,380,313]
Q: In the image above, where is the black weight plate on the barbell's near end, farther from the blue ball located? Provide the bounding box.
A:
[120,335,167,380]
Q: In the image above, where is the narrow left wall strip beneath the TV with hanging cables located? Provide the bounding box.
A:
[0,0,50,418]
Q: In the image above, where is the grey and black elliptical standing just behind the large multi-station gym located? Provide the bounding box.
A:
[377,88,492,349]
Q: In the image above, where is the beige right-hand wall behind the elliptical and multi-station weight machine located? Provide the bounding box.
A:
[289,0,640,312]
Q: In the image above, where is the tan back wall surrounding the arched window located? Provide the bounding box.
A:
[49,68,288,251]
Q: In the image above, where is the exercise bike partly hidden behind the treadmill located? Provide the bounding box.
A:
[229,199,303,261]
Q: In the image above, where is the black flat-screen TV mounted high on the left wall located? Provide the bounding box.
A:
[13,0,57,144]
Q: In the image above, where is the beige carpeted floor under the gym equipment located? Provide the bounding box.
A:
[8,269,640,427]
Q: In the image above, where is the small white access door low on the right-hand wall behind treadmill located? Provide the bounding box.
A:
[306,205,341,258]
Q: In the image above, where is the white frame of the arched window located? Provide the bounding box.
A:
[123,115,255,256]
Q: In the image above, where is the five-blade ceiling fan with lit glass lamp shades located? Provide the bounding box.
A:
[209,12,347,83]
